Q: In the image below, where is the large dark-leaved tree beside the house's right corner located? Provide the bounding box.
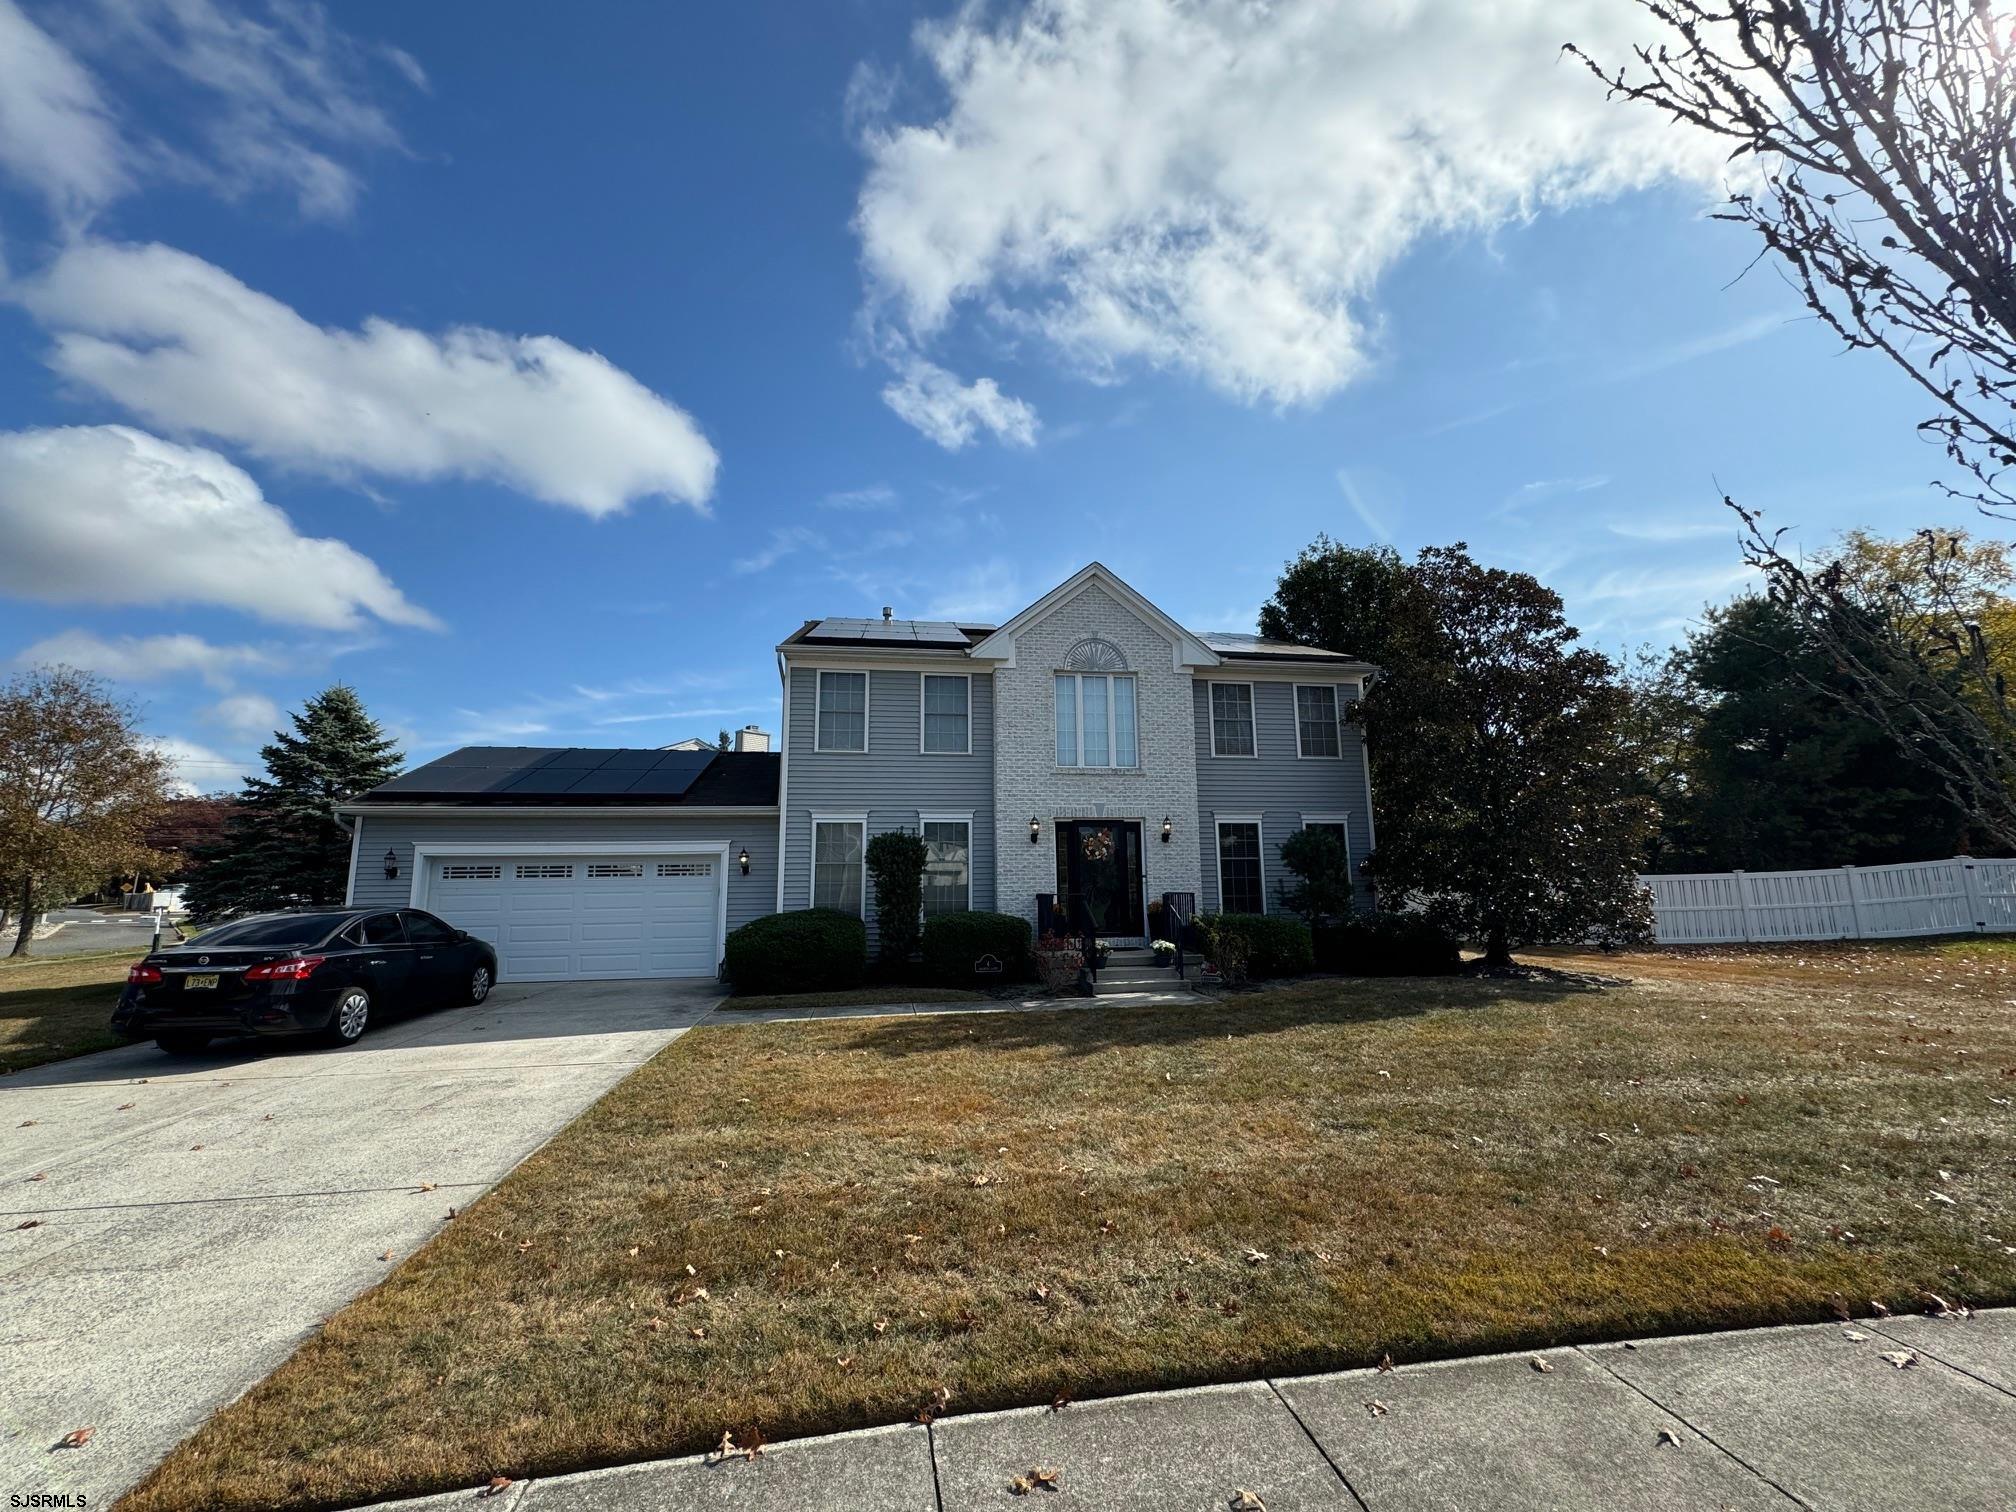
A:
[1353,544,1653,968]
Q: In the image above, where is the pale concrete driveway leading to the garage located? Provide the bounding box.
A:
[0,982,720,1506]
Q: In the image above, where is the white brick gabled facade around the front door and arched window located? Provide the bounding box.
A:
[994,583,1204,923]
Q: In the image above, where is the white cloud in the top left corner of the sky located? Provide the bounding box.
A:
[0,0,131,222]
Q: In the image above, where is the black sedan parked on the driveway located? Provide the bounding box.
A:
[113,909,498,1054]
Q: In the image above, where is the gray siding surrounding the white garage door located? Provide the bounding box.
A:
[351,808,776,929]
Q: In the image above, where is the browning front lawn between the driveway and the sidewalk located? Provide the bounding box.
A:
[125,946,2016,1512]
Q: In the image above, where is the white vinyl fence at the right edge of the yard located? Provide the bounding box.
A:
[1639,855,2016,946]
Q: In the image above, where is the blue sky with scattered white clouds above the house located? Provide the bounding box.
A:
[0,0,1958,788]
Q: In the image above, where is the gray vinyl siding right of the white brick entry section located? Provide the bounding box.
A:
[1195,677,1373,913]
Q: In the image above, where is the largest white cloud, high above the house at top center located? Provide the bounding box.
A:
[855,0,1724,409]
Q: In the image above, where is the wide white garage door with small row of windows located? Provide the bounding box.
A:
[421,853,722,982]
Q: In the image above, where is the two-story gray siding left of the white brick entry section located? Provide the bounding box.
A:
[784,667,994,935]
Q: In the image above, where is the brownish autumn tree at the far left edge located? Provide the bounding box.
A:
[0,667,169,956]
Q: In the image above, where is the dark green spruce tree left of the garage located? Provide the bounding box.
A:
[185,683,405,919]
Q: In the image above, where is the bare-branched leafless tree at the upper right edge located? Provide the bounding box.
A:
[1568,0,2016,849]
